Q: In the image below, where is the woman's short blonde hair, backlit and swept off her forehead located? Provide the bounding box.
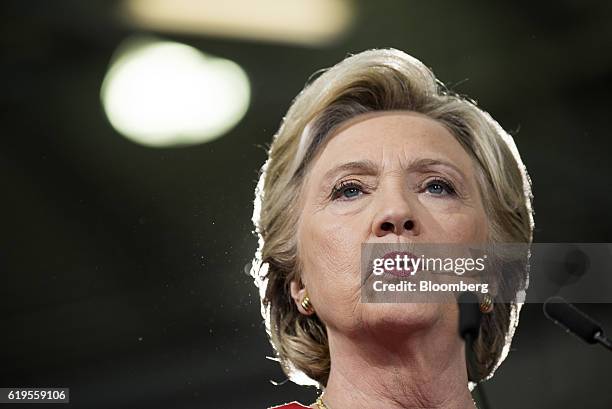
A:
[251,49,534,386]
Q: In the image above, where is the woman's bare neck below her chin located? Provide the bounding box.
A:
[324,318,476,409]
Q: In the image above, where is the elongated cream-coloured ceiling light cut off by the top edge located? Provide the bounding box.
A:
[120,0,355,45]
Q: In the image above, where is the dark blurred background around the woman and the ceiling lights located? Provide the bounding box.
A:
[0,0,612,409]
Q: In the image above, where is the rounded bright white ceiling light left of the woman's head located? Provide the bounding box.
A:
[101,39,250,147]
